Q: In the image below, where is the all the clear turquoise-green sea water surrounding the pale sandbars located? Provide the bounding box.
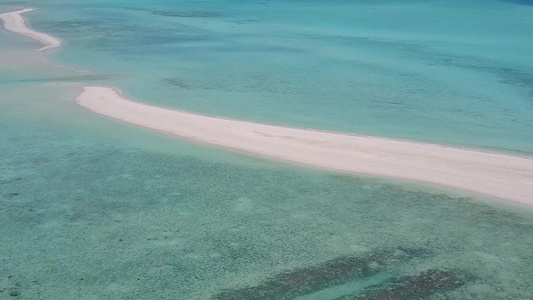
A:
[0,0,533,300]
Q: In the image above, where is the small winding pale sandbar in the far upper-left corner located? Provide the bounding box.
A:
[0,8,61,51]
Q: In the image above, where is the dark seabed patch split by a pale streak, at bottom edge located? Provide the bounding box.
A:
[213,248,464,300]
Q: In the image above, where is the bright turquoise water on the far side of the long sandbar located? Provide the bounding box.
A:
[22,0,533,154]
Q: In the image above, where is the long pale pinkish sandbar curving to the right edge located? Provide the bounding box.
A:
[76,87,533,205]
